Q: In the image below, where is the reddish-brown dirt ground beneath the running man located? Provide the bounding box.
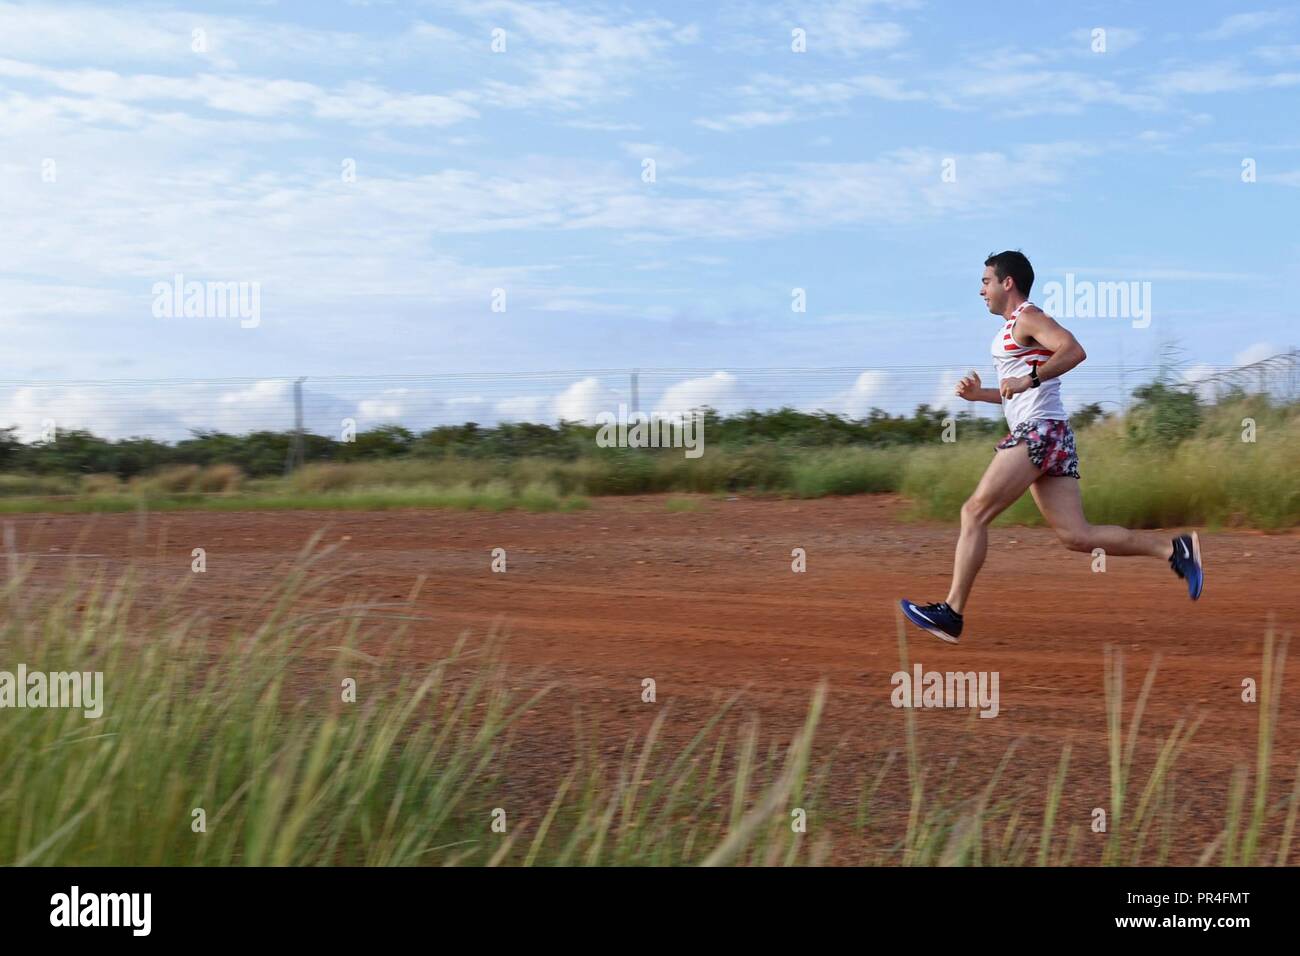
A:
[8,496,1300,862]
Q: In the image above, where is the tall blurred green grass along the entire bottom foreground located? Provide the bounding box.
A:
[0,545,1300,866]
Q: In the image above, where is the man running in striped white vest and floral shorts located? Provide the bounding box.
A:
[900,252,1204,644]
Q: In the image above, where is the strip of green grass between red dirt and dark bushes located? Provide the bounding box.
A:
[0,399,1300,529]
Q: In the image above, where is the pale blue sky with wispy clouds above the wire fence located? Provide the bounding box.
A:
[0,0,1300,437]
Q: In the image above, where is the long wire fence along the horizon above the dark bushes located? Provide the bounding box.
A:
[0,350,1300,442]
